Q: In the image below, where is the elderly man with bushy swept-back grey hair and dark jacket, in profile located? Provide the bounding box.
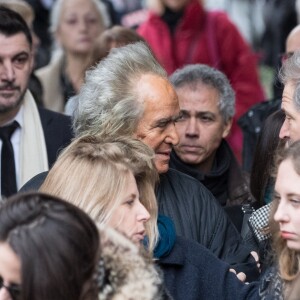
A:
[73,42,257,280]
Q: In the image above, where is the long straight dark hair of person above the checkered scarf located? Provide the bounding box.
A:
[250,110,285,206]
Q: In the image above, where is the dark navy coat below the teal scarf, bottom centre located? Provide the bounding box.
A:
[158,237,259,300]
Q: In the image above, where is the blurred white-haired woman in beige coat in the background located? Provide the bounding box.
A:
[36,0,109,112]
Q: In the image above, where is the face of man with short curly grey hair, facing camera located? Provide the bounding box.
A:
[174,84,231,172]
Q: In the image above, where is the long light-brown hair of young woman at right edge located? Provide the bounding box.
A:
[270,141,300,296]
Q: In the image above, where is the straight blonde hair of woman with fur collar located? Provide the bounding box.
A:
[40,136,158,253]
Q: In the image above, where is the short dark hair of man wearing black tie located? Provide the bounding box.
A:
[0,4,32,48]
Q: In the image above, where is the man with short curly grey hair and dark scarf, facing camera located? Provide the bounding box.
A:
[170,64,252,229]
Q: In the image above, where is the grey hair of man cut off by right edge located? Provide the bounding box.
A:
[278,51,300,111]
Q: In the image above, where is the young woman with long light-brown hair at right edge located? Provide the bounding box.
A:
[260,141,300,300]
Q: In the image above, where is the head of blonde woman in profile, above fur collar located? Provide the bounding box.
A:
[40,136,158,253]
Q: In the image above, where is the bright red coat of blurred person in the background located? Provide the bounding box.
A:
[138,0,265,160]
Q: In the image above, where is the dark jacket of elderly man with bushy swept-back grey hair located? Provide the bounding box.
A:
[156,169,259,281]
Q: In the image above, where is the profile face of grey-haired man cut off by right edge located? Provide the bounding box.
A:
[279,83,300,144]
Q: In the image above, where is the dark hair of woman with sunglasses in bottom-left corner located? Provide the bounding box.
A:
[0,192,99,300]
